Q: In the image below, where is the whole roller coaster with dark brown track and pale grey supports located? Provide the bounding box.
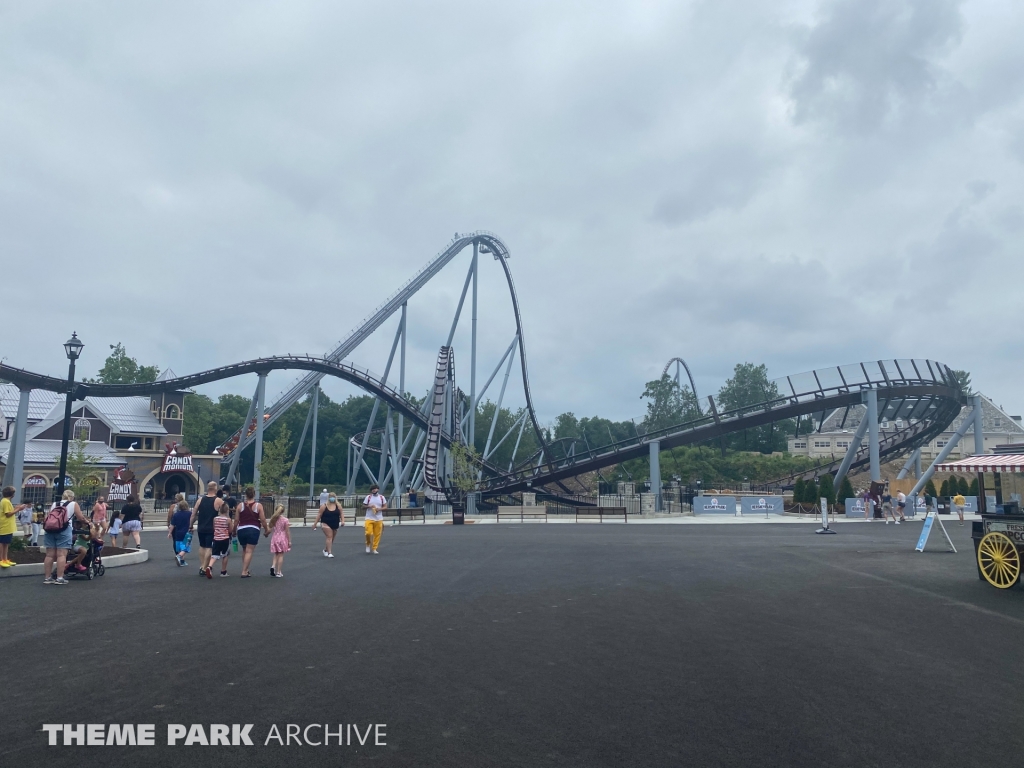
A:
[0,230,966,503]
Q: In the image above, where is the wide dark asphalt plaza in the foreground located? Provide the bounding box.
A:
[0,522,1024,768]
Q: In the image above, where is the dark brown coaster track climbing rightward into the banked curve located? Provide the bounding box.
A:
[482,360,966,493]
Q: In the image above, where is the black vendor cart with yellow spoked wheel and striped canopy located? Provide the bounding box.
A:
[935,445,1024,590]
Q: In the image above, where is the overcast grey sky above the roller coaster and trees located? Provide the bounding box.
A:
[0,0,1024,420]
